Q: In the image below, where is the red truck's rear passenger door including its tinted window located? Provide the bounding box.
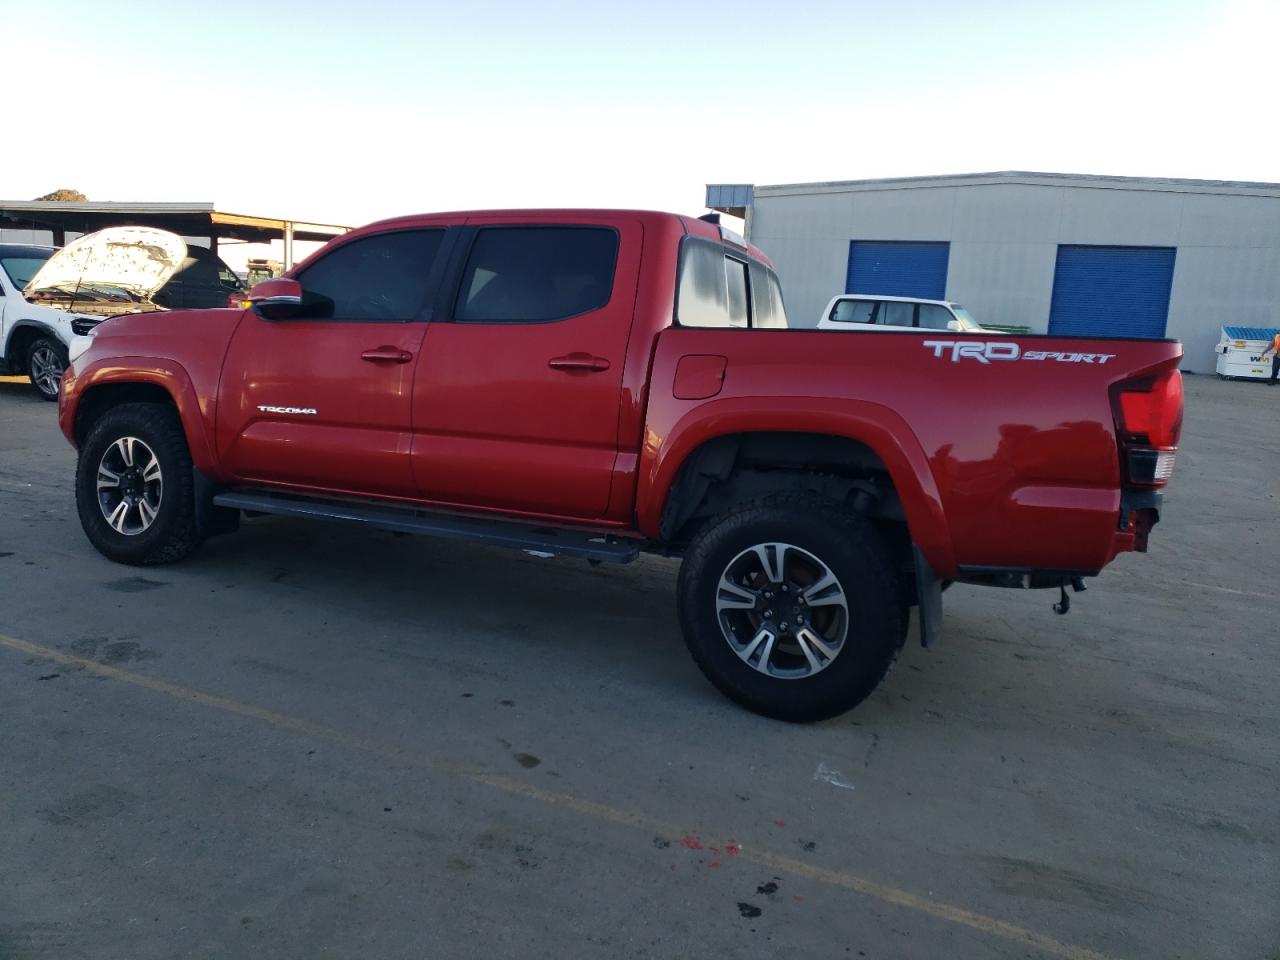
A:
[413,215,643,518]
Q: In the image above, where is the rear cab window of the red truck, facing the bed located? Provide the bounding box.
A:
[676,237,787,329]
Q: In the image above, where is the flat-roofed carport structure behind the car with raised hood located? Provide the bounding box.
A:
[0,200,351,268]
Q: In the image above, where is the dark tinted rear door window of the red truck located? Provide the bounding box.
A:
[454,227,618,324]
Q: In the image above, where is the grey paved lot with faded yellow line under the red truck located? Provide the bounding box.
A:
[0,376,1280,960]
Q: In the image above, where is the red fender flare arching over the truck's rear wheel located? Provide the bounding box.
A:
[636,397,956,575]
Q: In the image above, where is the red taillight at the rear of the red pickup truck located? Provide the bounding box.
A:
[1112,370,1183,486]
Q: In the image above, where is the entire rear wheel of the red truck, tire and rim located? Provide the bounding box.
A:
[680,494,904,721]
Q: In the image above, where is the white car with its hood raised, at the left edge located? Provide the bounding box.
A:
[0,227,187,401]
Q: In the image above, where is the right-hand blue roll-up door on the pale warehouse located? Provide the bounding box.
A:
[1048,247,1175,338]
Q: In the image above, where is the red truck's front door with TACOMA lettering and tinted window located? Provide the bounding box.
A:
[218,228,445,497]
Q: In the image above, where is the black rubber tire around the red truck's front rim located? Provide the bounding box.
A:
[76,403,201,566]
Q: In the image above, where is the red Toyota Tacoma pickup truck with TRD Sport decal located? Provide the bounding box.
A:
[60,210,1183,721]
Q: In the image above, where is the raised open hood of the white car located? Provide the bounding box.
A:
[23,227,187,300]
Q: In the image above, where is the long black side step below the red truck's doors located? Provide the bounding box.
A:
[214,492,650,563]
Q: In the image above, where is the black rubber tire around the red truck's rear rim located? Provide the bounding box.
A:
[678,494,906,722]
